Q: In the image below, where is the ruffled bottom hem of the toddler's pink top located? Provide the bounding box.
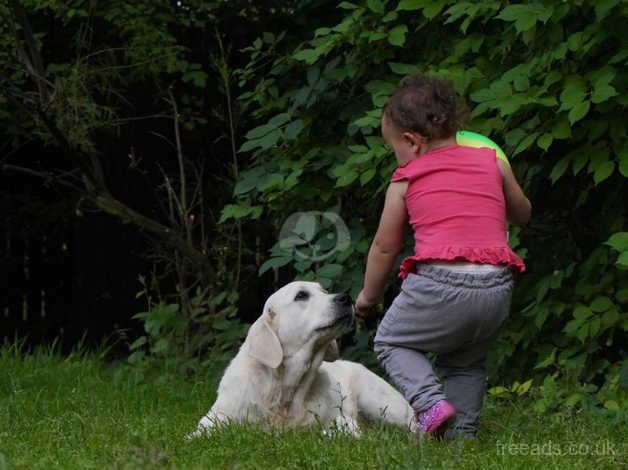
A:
[399,250,526,279]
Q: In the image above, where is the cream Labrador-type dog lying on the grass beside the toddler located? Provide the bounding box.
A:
[189,281,415,437]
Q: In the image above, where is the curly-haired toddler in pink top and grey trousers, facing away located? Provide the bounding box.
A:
[356,75,531,438]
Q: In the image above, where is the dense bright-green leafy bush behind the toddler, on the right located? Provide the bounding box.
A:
[223,0,628,408]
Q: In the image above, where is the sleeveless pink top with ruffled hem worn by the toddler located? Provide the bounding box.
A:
[391,145,525,279]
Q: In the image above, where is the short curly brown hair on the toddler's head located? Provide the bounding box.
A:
[384,73,466,140]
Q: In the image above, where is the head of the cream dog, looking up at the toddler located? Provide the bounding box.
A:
[247,281,353,369]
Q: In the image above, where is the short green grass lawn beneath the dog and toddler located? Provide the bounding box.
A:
[0,347,628,470]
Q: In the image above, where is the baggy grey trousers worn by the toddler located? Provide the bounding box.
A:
[375,264,513,437]
